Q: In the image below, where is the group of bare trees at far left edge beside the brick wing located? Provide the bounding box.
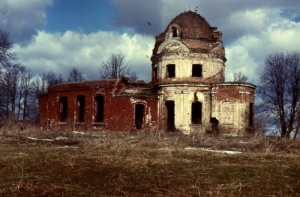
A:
[0,30,38,125]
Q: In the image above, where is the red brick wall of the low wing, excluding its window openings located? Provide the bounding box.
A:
[40,80,157,131]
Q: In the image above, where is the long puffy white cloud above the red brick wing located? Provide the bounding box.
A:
[13,31,154,80]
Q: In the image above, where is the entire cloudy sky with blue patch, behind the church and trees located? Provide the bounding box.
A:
[0,0,300,84]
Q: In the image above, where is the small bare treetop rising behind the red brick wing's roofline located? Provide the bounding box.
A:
[99,53,138,81]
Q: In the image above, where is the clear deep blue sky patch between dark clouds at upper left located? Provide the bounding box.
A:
[44,0,114,33]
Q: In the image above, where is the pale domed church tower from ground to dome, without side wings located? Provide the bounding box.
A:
[151,11,254,133]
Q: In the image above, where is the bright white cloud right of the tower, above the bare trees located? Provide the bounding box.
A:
[226,15,300,84]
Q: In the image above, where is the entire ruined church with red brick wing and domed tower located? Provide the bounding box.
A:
[39,11,256,133]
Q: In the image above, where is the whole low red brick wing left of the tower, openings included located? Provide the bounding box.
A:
[40,78,157,131]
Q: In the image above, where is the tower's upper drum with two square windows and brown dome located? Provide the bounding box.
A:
[151,11,226,84]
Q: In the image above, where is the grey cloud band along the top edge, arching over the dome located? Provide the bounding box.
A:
[110,0,300,43]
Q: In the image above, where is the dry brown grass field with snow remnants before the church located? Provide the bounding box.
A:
[0,129,300,196]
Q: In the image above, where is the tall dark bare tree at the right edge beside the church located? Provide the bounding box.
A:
[258,52,300,137]
